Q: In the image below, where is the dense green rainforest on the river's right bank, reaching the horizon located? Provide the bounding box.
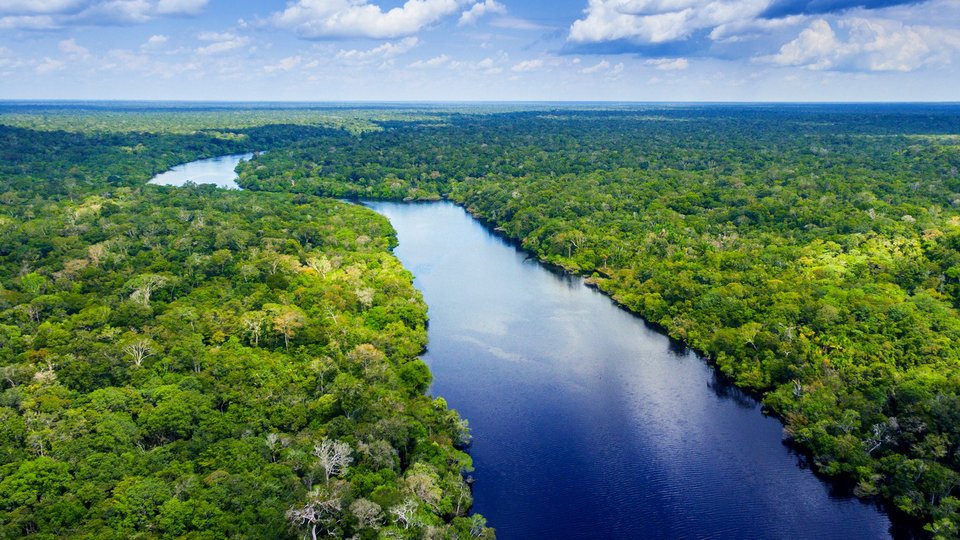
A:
[232,105,960,538]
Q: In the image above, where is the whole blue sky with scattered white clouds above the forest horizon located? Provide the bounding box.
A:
[0,0,960,102]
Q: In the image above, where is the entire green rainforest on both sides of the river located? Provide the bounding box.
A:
[0,105,960,538]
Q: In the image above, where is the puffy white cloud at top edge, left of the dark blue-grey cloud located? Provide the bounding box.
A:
[569,0,770,43]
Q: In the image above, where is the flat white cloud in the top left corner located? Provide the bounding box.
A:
[0,0,209,30]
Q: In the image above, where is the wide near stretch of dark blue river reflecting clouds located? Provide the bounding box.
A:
[368,202,890,540]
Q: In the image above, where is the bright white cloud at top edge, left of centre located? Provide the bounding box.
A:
[269,0,468,39]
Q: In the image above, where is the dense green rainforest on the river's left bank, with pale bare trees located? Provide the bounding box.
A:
[0,111,493,539]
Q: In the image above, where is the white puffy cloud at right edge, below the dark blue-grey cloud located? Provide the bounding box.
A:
[756,17,960,72]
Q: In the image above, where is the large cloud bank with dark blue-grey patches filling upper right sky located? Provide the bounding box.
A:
[567,0,960,72]
